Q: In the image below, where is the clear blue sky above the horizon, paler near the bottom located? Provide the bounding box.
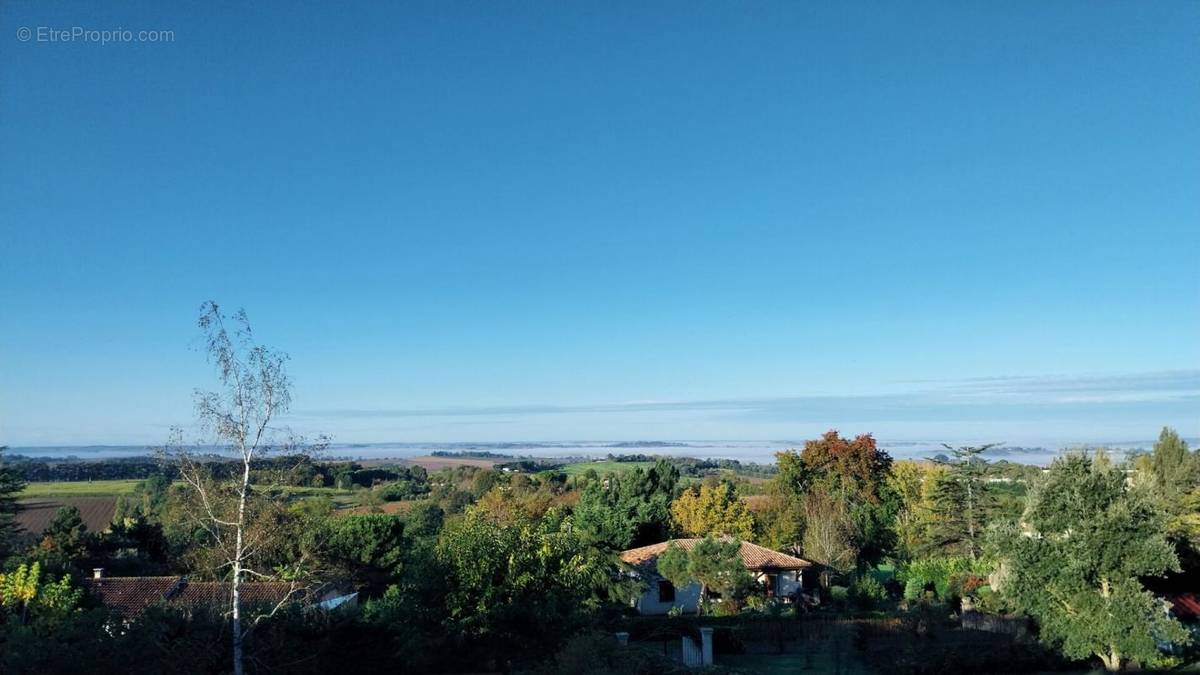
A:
[0,0,1200,446]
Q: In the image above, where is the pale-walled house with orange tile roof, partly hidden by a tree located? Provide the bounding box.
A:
[620,538,812,615]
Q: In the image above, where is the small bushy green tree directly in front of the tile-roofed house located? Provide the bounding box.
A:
[656,537,754,611]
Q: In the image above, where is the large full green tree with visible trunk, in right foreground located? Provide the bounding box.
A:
[995,455,1188,670]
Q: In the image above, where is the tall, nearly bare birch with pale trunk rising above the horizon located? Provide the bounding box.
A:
[167,301,325,675]
